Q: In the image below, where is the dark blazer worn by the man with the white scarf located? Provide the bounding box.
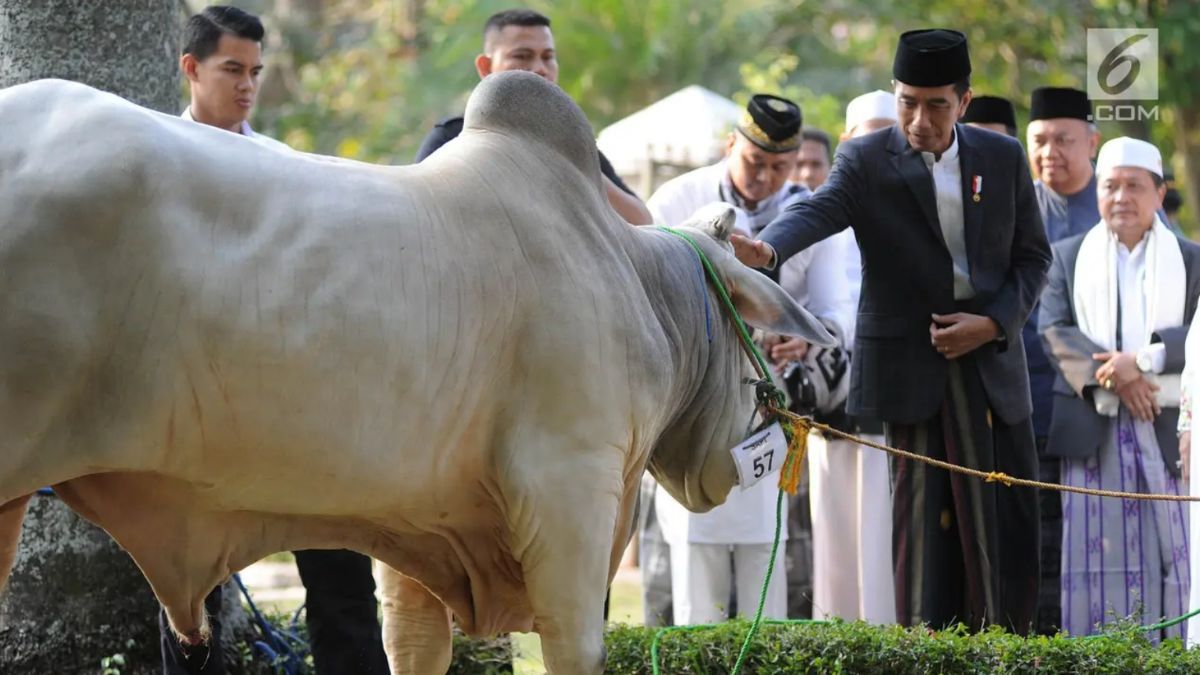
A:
[1038,234,1200,476]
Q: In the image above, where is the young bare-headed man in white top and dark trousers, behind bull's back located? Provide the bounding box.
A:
[158,5,389,675]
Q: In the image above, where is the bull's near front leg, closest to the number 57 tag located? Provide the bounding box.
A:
[521,476,619,675]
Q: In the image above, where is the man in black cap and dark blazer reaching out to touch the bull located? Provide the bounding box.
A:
[734,30,1050,632]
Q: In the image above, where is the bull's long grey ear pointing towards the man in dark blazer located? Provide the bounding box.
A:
[718,255,838,347]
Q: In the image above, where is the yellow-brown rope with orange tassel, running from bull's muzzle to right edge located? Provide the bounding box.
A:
[768,406,1200,502]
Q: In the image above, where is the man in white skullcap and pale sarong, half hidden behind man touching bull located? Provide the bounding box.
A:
[796,90,896,623]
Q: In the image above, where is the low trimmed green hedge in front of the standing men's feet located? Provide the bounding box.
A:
[605,621,1200,675]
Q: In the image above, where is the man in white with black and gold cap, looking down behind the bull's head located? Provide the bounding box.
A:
[647,94,852,625]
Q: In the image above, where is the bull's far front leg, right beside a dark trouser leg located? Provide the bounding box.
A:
[378,563,451,675]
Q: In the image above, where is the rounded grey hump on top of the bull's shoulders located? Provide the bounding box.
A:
[464,71,600,179]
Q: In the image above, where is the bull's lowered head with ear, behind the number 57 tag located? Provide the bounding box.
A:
[649,204,835,512]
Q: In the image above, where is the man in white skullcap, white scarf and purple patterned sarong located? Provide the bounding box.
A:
[1038,138,1200,640]
